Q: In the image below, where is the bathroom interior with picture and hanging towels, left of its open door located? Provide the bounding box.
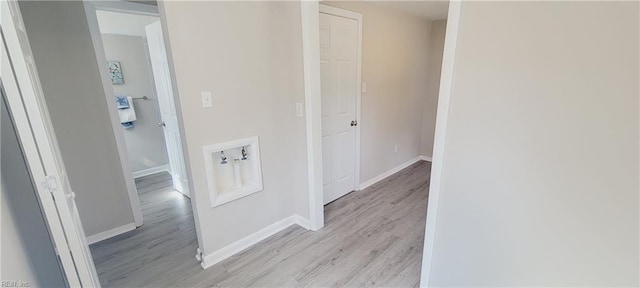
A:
[96,10,169,182]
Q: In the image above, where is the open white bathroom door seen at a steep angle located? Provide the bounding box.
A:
[145,21,189,196]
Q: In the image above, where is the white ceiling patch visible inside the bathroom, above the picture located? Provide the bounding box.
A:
[96,10,160,36]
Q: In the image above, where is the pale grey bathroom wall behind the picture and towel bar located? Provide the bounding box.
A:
[102,34,168,172]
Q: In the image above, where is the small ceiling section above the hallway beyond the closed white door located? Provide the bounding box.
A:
[373,0,449,20]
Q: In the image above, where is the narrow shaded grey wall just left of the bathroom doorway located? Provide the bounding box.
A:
[20,1,134,236]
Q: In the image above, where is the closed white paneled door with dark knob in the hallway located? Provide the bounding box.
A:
[320,13,358,204]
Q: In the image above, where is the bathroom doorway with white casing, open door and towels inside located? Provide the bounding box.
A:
[85,2,190,234]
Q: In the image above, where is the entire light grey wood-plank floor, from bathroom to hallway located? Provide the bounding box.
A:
[91,161,431,287]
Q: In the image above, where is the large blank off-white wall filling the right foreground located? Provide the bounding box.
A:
[430,2,640,287]
